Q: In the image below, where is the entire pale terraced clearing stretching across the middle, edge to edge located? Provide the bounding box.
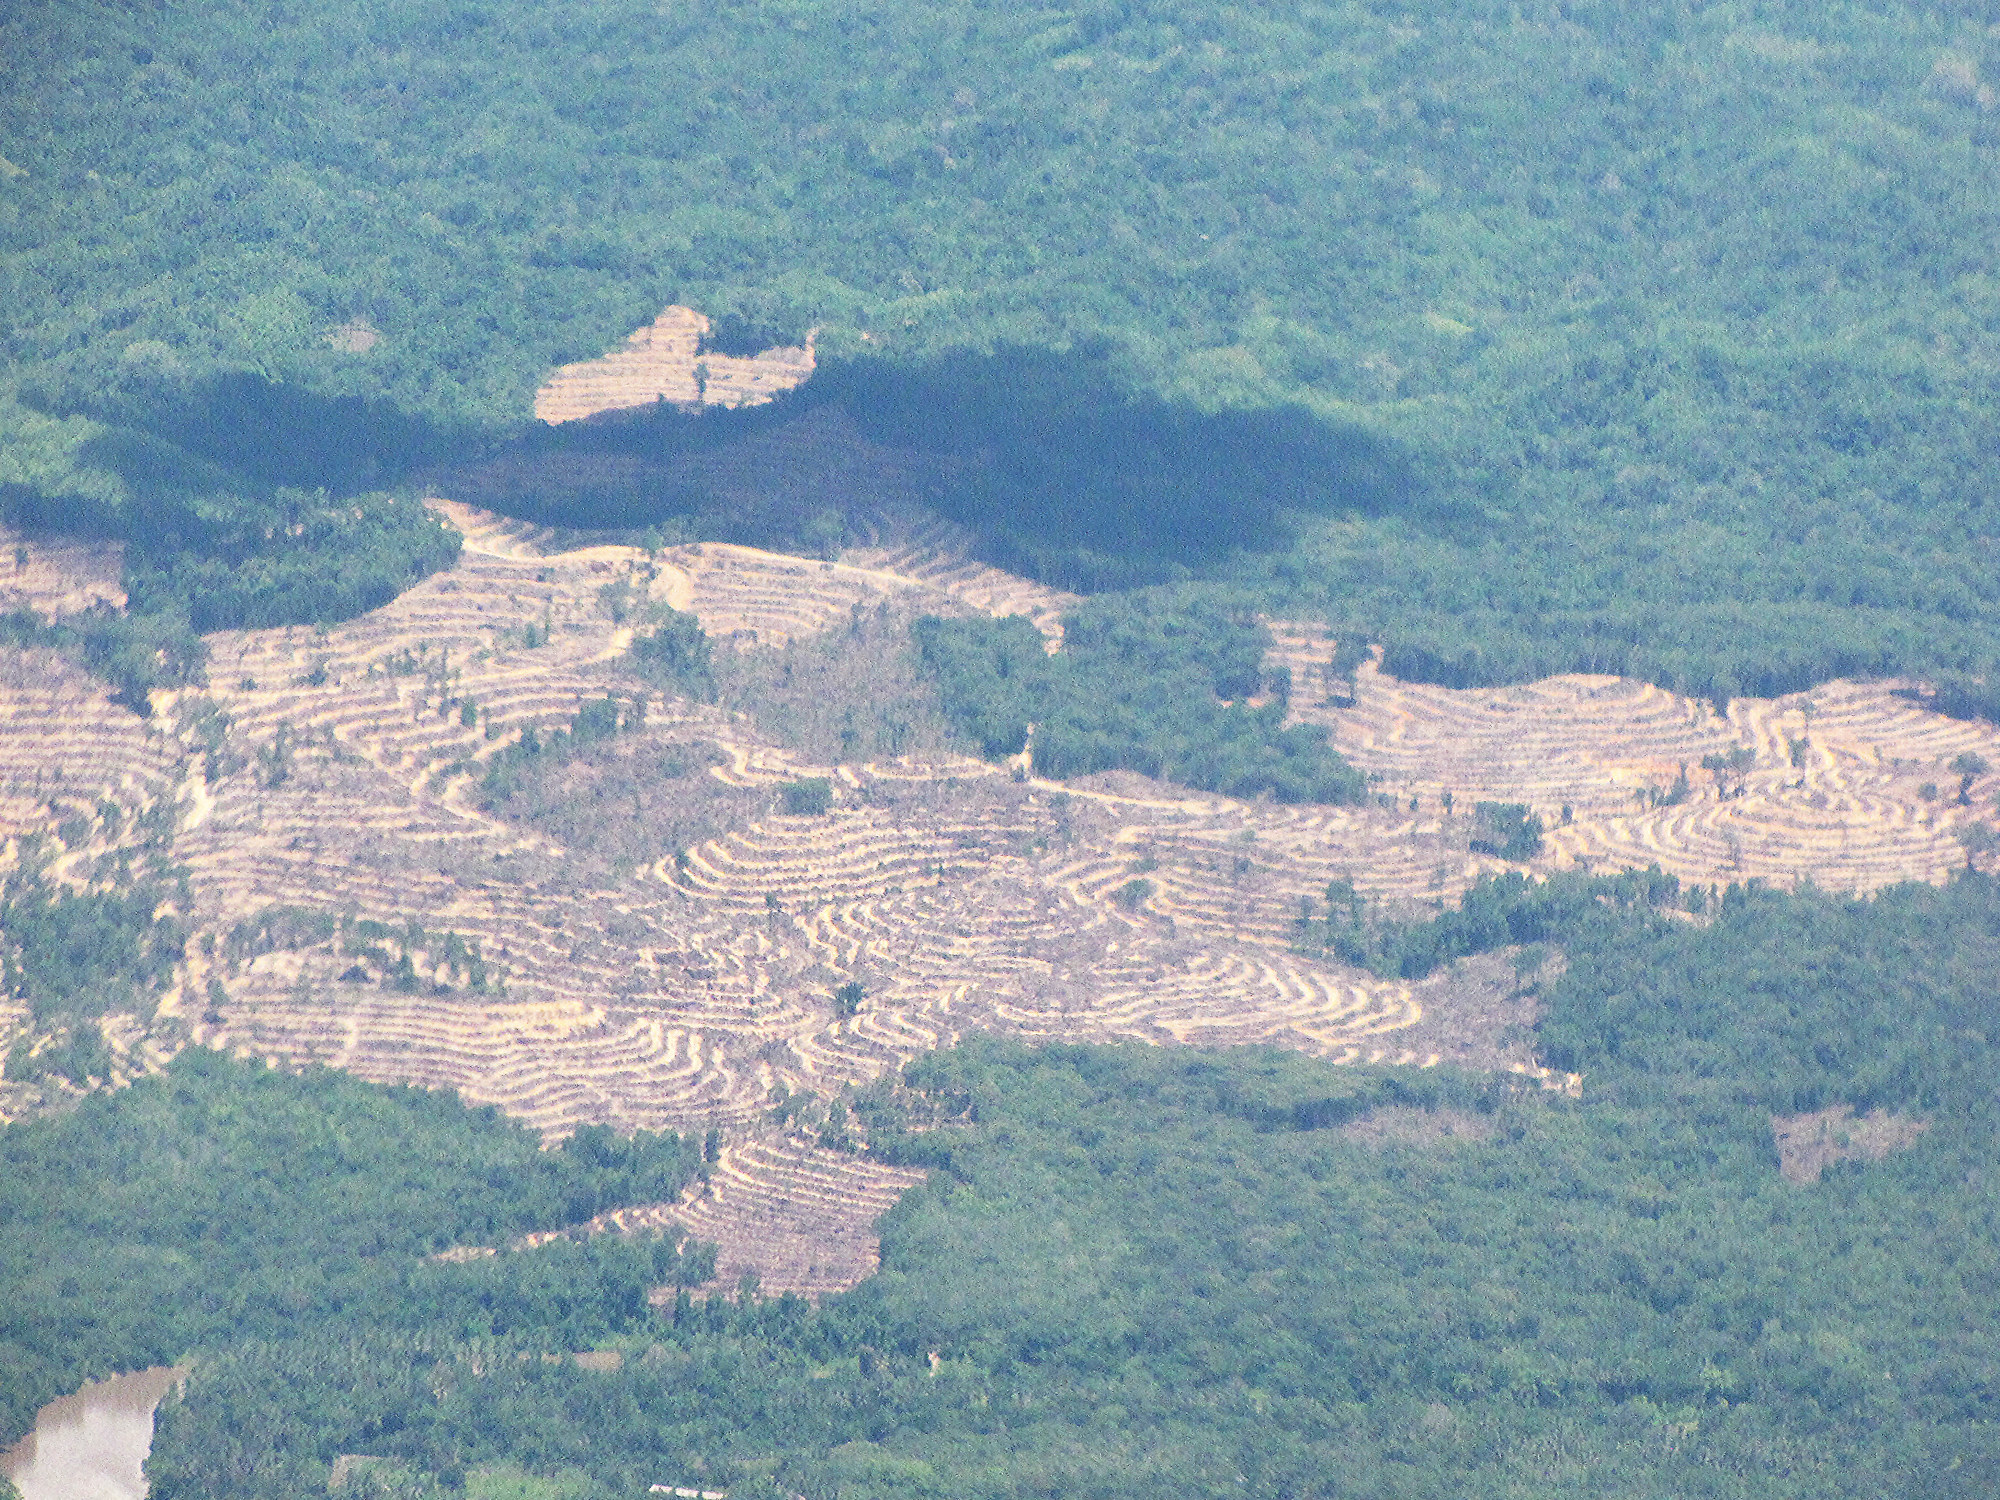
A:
[0,516,2000,1294]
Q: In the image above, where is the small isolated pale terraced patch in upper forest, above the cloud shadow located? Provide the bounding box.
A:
[534,306,812,422]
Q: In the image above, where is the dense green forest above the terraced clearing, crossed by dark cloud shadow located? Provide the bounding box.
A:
[0,0,2000,704]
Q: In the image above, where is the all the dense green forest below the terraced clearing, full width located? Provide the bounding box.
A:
[0,876,2000,1500]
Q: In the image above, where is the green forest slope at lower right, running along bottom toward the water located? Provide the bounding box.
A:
[133,876,2000,1500]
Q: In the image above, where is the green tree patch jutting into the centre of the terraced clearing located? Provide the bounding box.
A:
[914,598,1362,802]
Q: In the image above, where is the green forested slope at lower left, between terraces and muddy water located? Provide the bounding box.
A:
[0,1050,700,1438]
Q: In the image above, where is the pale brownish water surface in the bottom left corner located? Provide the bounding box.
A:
[0,1368,186,1500]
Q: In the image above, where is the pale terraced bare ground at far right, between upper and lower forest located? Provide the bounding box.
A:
[1272,622,2000,892]
